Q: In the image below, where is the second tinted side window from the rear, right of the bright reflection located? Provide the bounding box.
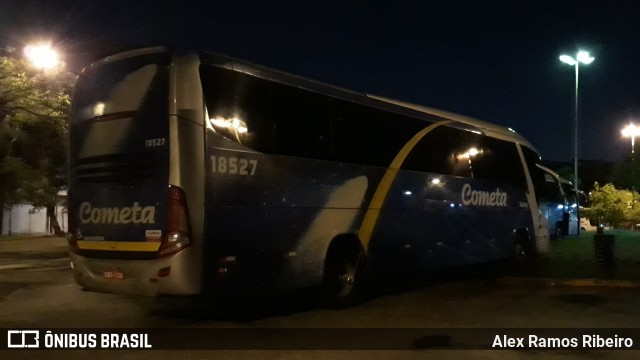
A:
[271,83,331,159]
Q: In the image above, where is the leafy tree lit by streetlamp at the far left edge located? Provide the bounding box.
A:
[0,56,73,233]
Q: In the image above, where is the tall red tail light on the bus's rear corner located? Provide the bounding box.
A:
[158,186,191,256]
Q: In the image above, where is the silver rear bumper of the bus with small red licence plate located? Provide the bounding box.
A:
[69,248,201,296]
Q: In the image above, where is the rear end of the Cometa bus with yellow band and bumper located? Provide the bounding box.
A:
[68,48,202,295]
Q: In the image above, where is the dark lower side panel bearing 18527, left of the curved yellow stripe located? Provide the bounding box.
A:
[205,132,384,291]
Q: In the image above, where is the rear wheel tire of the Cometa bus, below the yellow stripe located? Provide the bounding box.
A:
[322,240,365,309]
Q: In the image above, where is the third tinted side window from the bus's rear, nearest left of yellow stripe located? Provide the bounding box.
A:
[331,99,392,166]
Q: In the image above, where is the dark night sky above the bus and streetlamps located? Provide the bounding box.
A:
[0,0,640,161]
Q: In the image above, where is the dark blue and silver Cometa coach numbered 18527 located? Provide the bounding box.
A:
[68,47,549,306]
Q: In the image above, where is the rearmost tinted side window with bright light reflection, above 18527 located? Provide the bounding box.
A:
[200,65,273,152]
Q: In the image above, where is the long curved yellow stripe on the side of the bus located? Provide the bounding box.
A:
[360,121,451,251]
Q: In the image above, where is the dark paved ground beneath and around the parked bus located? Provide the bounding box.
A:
[0,234,640,359]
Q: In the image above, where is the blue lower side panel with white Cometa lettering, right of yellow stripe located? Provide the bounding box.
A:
[370,172,531,276]
